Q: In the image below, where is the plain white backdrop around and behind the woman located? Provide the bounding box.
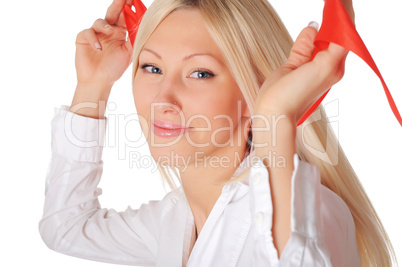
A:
[0,0,402,266]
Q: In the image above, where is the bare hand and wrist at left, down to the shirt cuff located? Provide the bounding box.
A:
[70,0,133,119]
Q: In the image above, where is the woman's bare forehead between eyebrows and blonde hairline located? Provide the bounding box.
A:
[144,8,223,62]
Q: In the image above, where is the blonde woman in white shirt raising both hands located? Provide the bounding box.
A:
[40,0,393,266]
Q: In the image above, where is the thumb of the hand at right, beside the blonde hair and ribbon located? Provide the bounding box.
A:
[283,22,318,70]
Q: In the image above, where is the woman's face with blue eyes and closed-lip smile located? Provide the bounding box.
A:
[133,9,249,168]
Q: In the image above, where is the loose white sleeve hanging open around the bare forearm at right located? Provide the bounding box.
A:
[250,154,361,267]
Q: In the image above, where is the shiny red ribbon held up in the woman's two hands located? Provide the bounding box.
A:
[123,0,402,126]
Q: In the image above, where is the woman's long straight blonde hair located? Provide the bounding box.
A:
[133,0,396,267]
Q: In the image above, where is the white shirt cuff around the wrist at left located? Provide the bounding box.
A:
[51,106,107,162]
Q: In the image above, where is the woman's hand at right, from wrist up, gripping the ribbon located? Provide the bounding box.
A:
[254,0,354,124]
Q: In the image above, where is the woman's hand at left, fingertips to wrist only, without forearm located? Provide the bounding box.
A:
[75,0,133,86]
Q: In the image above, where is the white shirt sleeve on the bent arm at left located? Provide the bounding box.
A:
[39,106,162,266]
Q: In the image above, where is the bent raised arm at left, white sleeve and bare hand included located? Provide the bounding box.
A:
[39,0,163,265]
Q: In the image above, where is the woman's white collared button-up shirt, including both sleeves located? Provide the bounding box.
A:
[39,106,361,267]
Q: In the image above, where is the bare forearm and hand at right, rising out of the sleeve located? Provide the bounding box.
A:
[253,0,354,260]
